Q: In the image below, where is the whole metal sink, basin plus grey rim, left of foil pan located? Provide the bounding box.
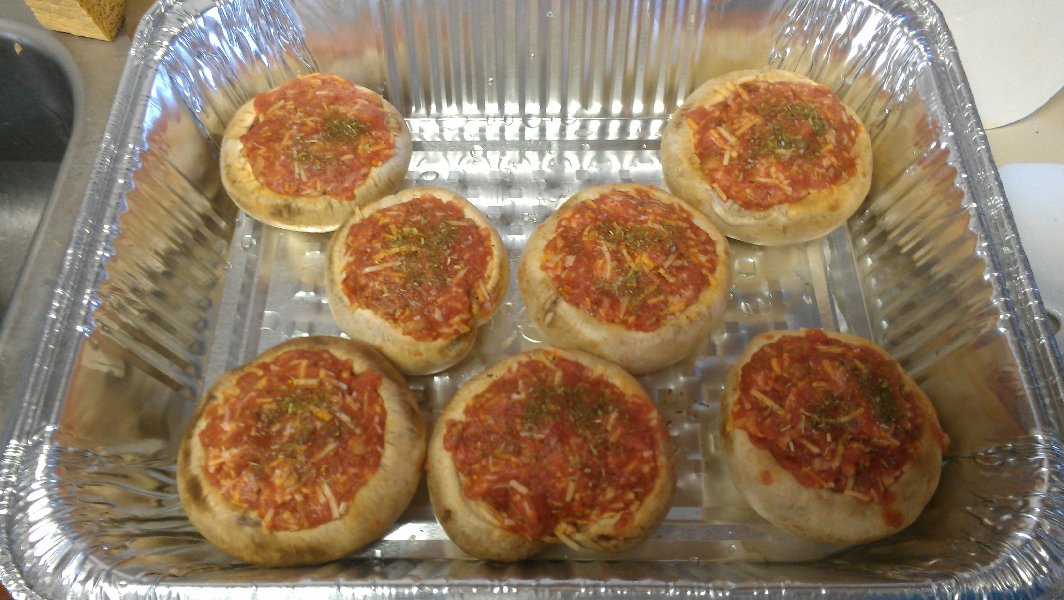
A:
[0,7,128,436]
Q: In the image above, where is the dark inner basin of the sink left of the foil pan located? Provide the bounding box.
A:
[0,20,74,321]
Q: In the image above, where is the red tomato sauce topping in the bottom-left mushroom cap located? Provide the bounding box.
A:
[199,350,386,531]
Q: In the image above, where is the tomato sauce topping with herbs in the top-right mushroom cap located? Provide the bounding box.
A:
[687,80,862,211]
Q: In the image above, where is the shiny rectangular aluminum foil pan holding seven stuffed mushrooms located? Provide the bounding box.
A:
[0,0,1064,598]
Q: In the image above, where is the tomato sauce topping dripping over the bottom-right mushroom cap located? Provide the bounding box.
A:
[727,330,948,504]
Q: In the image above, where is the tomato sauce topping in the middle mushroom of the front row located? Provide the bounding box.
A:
[444,354,668,539]
